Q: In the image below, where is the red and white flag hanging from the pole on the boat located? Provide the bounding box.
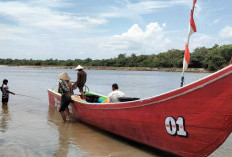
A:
[183,0,197,73]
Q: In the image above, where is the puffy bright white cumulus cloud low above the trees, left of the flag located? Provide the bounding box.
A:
[103,23,171,53]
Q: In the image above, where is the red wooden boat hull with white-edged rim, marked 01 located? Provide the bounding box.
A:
[48,65,232,156]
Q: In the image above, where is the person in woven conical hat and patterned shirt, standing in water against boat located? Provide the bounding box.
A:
[58,72,73,121]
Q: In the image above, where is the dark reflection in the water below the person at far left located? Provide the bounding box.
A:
[0,104,10,133]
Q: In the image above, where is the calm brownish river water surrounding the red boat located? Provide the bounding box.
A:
[0,66,232,157]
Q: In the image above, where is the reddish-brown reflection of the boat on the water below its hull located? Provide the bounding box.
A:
[48,106,178,157]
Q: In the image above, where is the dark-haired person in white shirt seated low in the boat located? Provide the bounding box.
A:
[108,83,125,103]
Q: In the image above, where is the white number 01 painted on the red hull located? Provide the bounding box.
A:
[165,117,188,136]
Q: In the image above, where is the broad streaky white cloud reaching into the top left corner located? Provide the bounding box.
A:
[0,1,107,31]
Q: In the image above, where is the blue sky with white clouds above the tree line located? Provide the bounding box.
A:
[0,0,232,59]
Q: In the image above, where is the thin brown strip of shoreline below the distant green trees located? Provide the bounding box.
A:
[0,65,210,73]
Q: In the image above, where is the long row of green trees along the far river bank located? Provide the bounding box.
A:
[0,44,232,71]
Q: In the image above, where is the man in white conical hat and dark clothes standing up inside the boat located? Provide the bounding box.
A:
[74,65,87,99]
